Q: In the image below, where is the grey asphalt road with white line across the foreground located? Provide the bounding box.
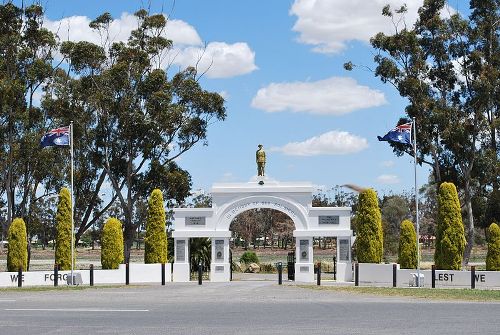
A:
[0,281,500,335]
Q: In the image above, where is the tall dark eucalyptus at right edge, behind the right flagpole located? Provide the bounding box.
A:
[345,0,499,263]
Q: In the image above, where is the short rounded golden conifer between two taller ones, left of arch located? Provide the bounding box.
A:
[101,218,124,269]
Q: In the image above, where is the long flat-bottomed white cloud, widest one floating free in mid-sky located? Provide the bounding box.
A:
[252,77,386,115]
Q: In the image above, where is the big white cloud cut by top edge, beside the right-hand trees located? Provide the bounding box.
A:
[290,0,455,53]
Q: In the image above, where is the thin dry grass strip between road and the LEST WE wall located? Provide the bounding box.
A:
[299,285,500,302]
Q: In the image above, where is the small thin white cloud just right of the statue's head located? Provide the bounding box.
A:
[271,130,368,156]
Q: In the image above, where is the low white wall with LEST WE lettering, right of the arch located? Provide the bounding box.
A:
[358,263,500,289]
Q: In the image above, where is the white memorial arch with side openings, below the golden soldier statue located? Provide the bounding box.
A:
[172,179,352,282]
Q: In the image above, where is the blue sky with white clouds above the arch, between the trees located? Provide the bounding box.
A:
[15,0,468,197]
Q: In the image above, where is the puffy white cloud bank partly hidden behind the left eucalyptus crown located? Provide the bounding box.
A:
[45,13,257,78]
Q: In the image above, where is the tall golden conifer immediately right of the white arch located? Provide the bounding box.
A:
[356,189,384,263]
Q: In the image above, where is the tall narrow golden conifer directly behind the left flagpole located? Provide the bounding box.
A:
[55,187,76,270]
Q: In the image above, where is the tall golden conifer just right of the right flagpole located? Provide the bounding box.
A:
[434,182,465,270]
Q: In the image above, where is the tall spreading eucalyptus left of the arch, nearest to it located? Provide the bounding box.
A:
[56,9,226,260]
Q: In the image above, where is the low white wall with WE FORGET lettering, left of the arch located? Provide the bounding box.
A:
[0,263,172,287]
